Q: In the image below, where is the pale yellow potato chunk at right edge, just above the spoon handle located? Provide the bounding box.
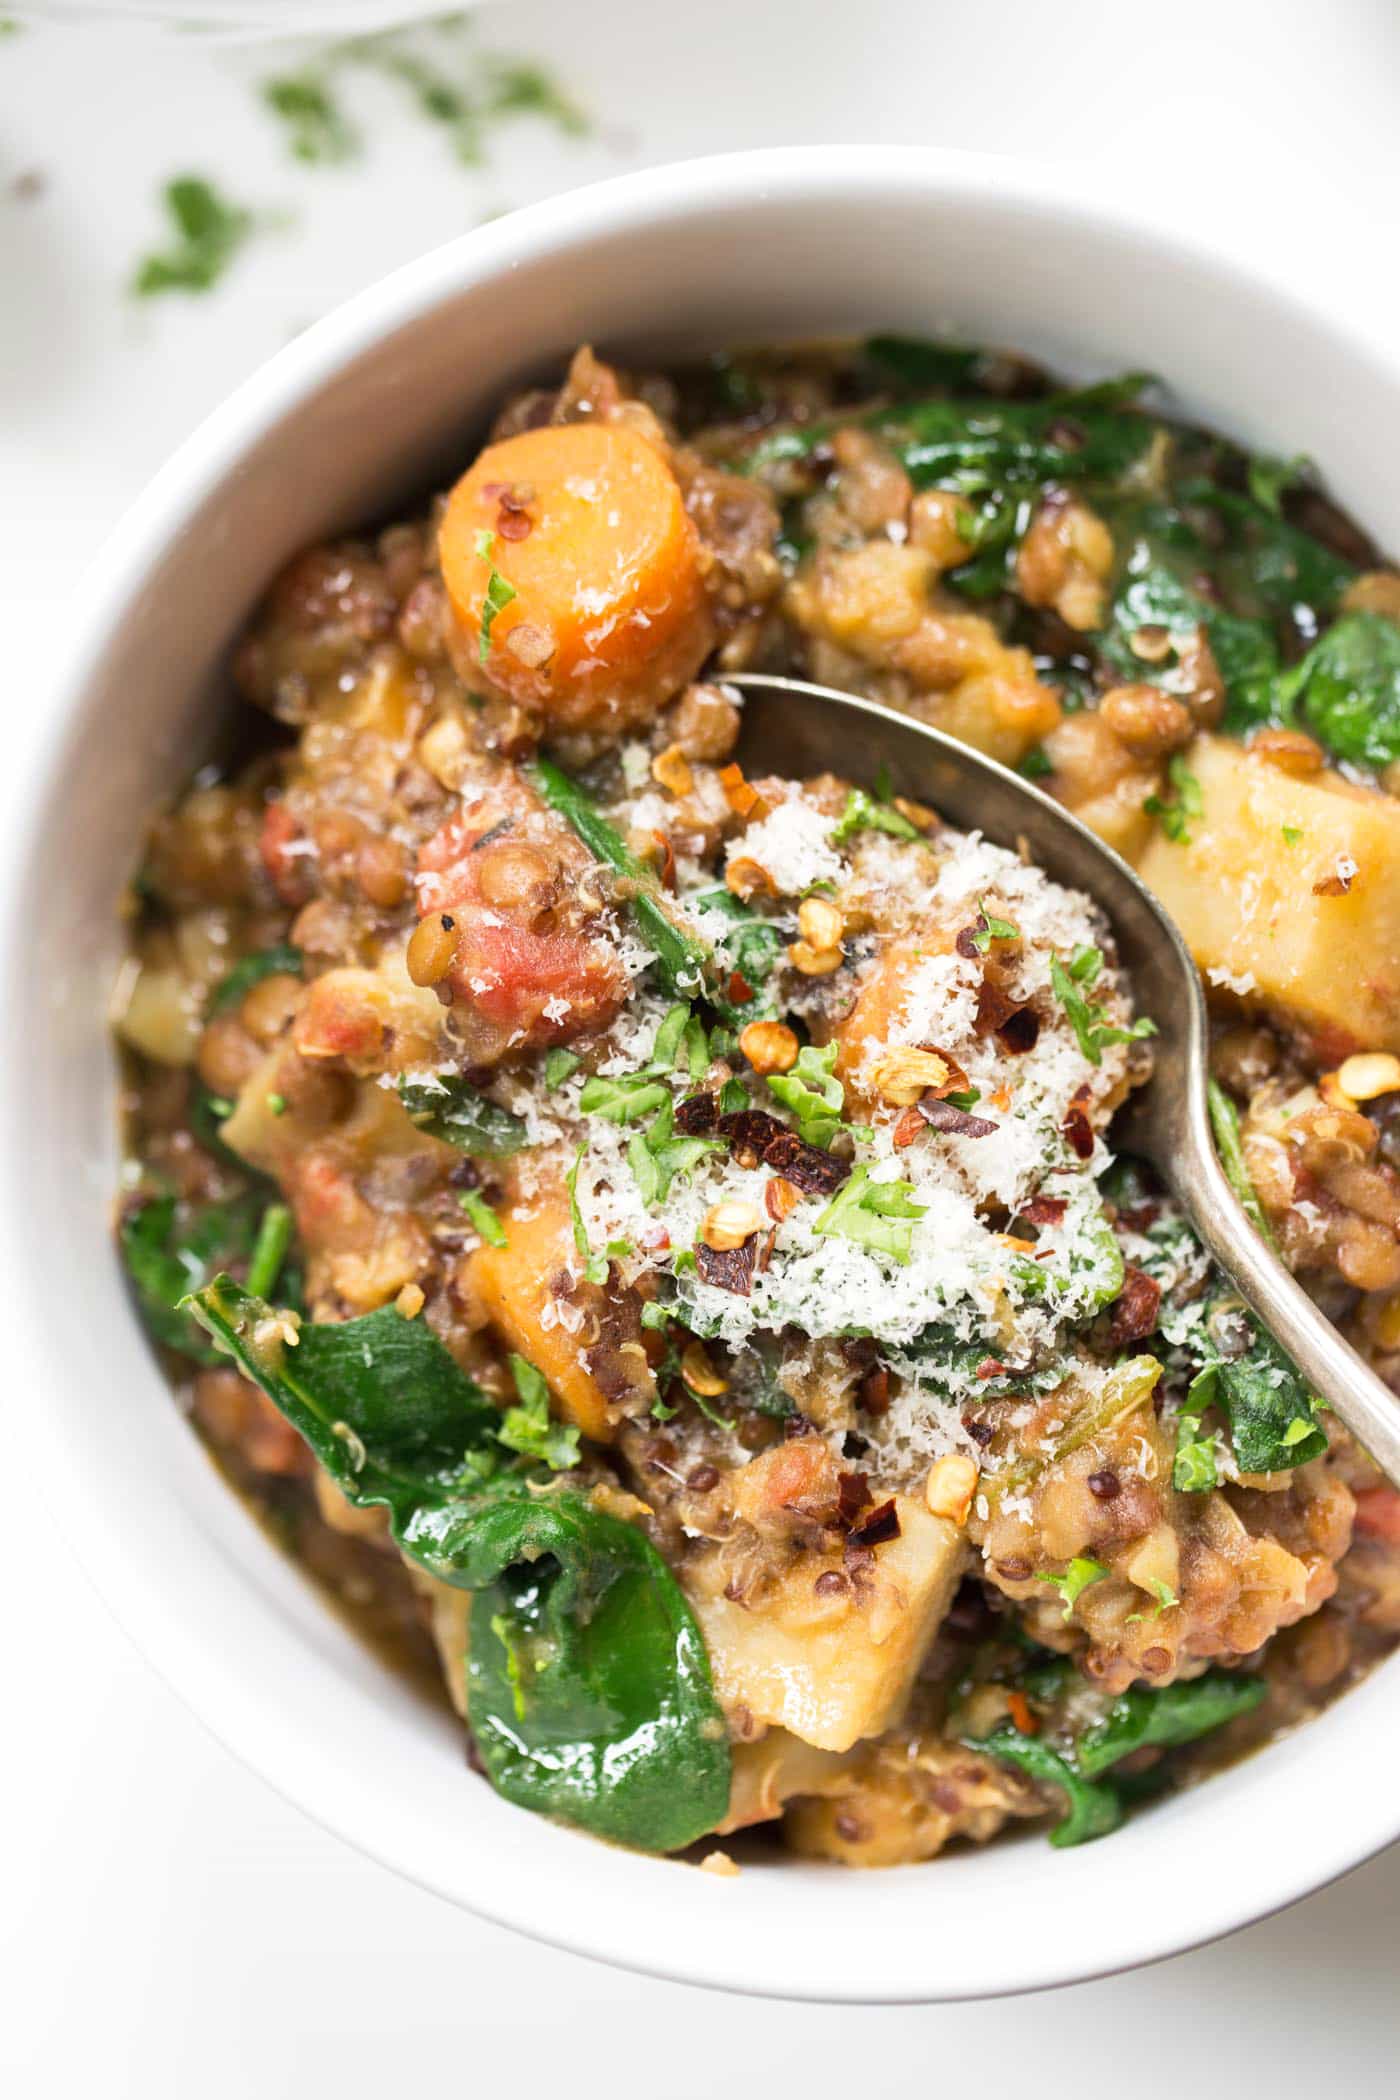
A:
[1138,737,1400,1061]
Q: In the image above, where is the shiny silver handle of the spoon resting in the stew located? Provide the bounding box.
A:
[1159,1094,1400,1485]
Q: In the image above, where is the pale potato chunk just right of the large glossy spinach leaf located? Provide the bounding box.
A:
[682,1495,966,1751]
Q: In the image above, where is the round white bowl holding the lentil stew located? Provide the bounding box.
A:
[2,147,1400,2001]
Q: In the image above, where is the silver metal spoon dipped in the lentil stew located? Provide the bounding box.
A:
[724,672,1400,1483]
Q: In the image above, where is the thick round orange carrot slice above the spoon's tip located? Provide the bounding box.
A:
[439,422,714,731]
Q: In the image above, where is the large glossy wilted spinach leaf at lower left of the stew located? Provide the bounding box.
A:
[183,1277,730,1852]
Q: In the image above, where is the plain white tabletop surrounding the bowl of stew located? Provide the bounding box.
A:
[0,0,1400,2100]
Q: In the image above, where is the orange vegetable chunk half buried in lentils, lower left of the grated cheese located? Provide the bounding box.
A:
[472,1187,613,1443]
